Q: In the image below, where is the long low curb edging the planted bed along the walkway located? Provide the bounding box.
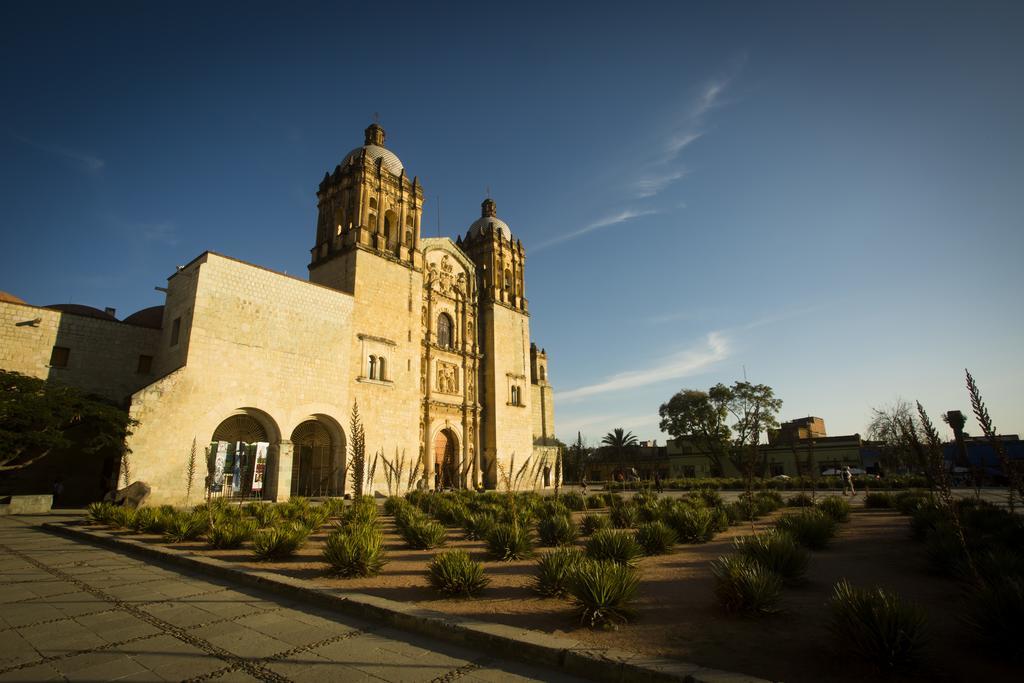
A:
[42,522,767,683]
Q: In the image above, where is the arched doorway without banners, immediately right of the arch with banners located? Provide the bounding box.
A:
[292,419,345,497]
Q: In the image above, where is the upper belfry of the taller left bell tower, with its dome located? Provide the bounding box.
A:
[309,123,423,292]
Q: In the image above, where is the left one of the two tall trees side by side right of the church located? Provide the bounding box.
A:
[657,384,732,476]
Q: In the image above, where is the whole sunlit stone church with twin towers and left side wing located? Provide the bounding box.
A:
[0,124,557,504]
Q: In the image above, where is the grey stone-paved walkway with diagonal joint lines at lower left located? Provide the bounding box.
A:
[0,517,577,683]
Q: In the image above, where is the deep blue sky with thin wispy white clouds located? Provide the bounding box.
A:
[0,2,1024,442]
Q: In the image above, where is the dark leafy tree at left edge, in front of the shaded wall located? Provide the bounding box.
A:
[0,370,138,471]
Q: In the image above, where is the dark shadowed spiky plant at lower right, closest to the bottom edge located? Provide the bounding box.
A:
[829,580,927,674]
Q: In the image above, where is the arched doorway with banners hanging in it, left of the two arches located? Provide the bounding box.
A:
[209,413,270,498]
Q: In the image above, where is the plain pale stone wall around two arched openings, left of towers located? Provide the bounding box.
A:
[128,253,354,505]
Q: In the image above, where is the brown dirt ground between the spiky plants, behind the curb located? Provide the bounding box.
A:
[105,509,1021,683]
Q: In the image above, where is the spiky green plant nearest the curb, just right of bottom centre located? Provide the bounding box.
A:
[568,558,640,629]
